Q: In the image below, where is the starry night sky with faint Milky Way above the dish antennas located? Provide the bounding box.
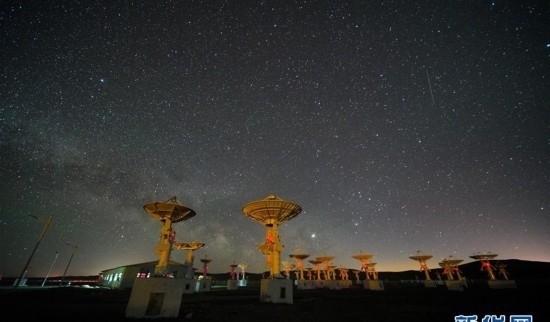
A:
[0,0,550,277]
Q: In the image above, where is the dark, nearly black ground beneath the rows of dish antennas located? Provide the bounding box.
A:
[0,282,550,322]
